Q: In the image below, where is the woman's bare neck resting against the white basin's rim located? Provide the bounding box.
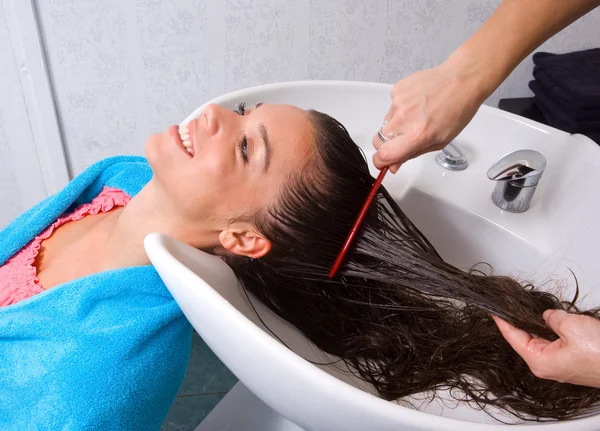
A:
[99,181,219,266]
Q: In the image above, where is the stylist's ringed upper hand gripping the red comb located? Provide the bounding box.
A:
[373,58,487,173]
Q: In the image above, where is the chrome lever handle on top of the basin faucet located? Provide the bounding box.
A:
[487,150,546,187]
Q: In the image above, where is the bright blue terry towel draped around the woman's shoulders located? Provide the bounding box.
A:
[0,157,192,431]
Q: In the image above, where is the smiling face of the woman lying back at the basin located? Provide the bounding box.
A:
[146,104,315,228]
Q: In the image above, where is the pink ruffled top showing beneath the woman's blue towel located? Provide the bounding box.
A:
[0,187,131,307]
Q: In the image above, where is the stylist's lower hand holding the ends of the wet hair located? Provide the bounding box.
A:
[492,310,600,388]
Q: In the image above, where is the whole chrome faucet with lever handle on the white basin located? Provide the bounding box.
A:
[488,150,546,213]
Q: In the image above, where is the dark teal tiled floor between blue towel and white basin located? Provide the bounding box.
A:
[160,332,237,431]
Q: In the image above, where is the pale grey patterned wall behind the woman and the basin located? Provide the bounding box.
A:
[0,0,600,226]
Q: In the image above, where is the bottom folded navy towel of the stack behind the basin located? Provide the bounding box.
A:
[529,81,600,134]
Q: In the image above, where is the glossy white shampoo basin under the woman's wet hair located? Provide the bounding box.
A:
[145,81,600,431]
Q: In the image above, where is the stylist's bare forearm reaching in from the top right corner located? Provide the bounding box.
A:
[446,0,600,102]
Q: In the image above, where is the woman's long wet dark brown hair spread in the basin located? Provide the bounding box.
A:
[226,111,600,420]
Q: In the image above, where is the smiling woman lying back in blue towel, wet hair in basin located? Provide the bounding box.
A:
[0,104,600,430]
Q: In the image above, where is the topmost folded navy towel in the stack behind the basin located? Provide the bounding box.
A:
[533,48,600,109]
